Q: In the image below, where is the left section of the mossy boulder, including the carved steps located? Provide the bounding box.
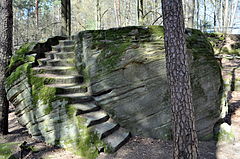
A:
[5,37,130,158]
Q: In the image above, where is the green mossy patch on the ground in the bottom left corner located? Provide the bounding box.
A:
[0,142,19,159]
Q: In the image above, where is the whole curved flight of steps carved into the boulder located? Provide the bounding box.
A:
[33,40,130,151]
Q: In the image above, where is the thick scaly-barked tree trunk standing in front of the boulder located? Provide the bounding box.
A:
[162,0,198,159]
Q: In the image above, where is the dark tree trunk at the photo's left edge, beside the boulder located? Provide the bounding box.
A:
[0,0,13,134]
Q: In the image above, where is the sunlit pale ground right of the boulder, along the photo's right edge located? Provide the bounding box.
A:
[216,56,240,159]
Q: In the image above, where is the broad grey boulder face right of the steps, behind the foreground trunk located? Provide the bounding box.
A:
[76,26,222,139]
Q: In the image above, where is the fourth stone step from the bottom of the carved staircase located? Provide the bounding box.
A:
[71,102,100,115]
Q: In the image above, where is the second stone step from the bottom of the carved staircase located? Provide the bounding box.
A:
[90,119,119,139]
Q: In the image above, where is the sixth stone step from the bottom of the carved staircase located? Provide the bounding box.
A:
[47,84,88,94]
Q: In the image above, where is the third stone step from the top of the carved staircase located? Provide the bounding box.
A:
[45,51,75,60]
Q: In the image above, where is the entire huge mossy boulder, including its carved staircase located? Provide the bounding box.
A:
[5,26,223,158]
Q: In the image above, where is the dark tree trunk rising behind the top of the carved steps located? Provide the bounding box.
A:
[61,0,71,36]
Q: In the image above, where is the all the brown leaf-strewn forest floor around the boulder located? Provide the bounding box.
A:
[0,56,240,159]
